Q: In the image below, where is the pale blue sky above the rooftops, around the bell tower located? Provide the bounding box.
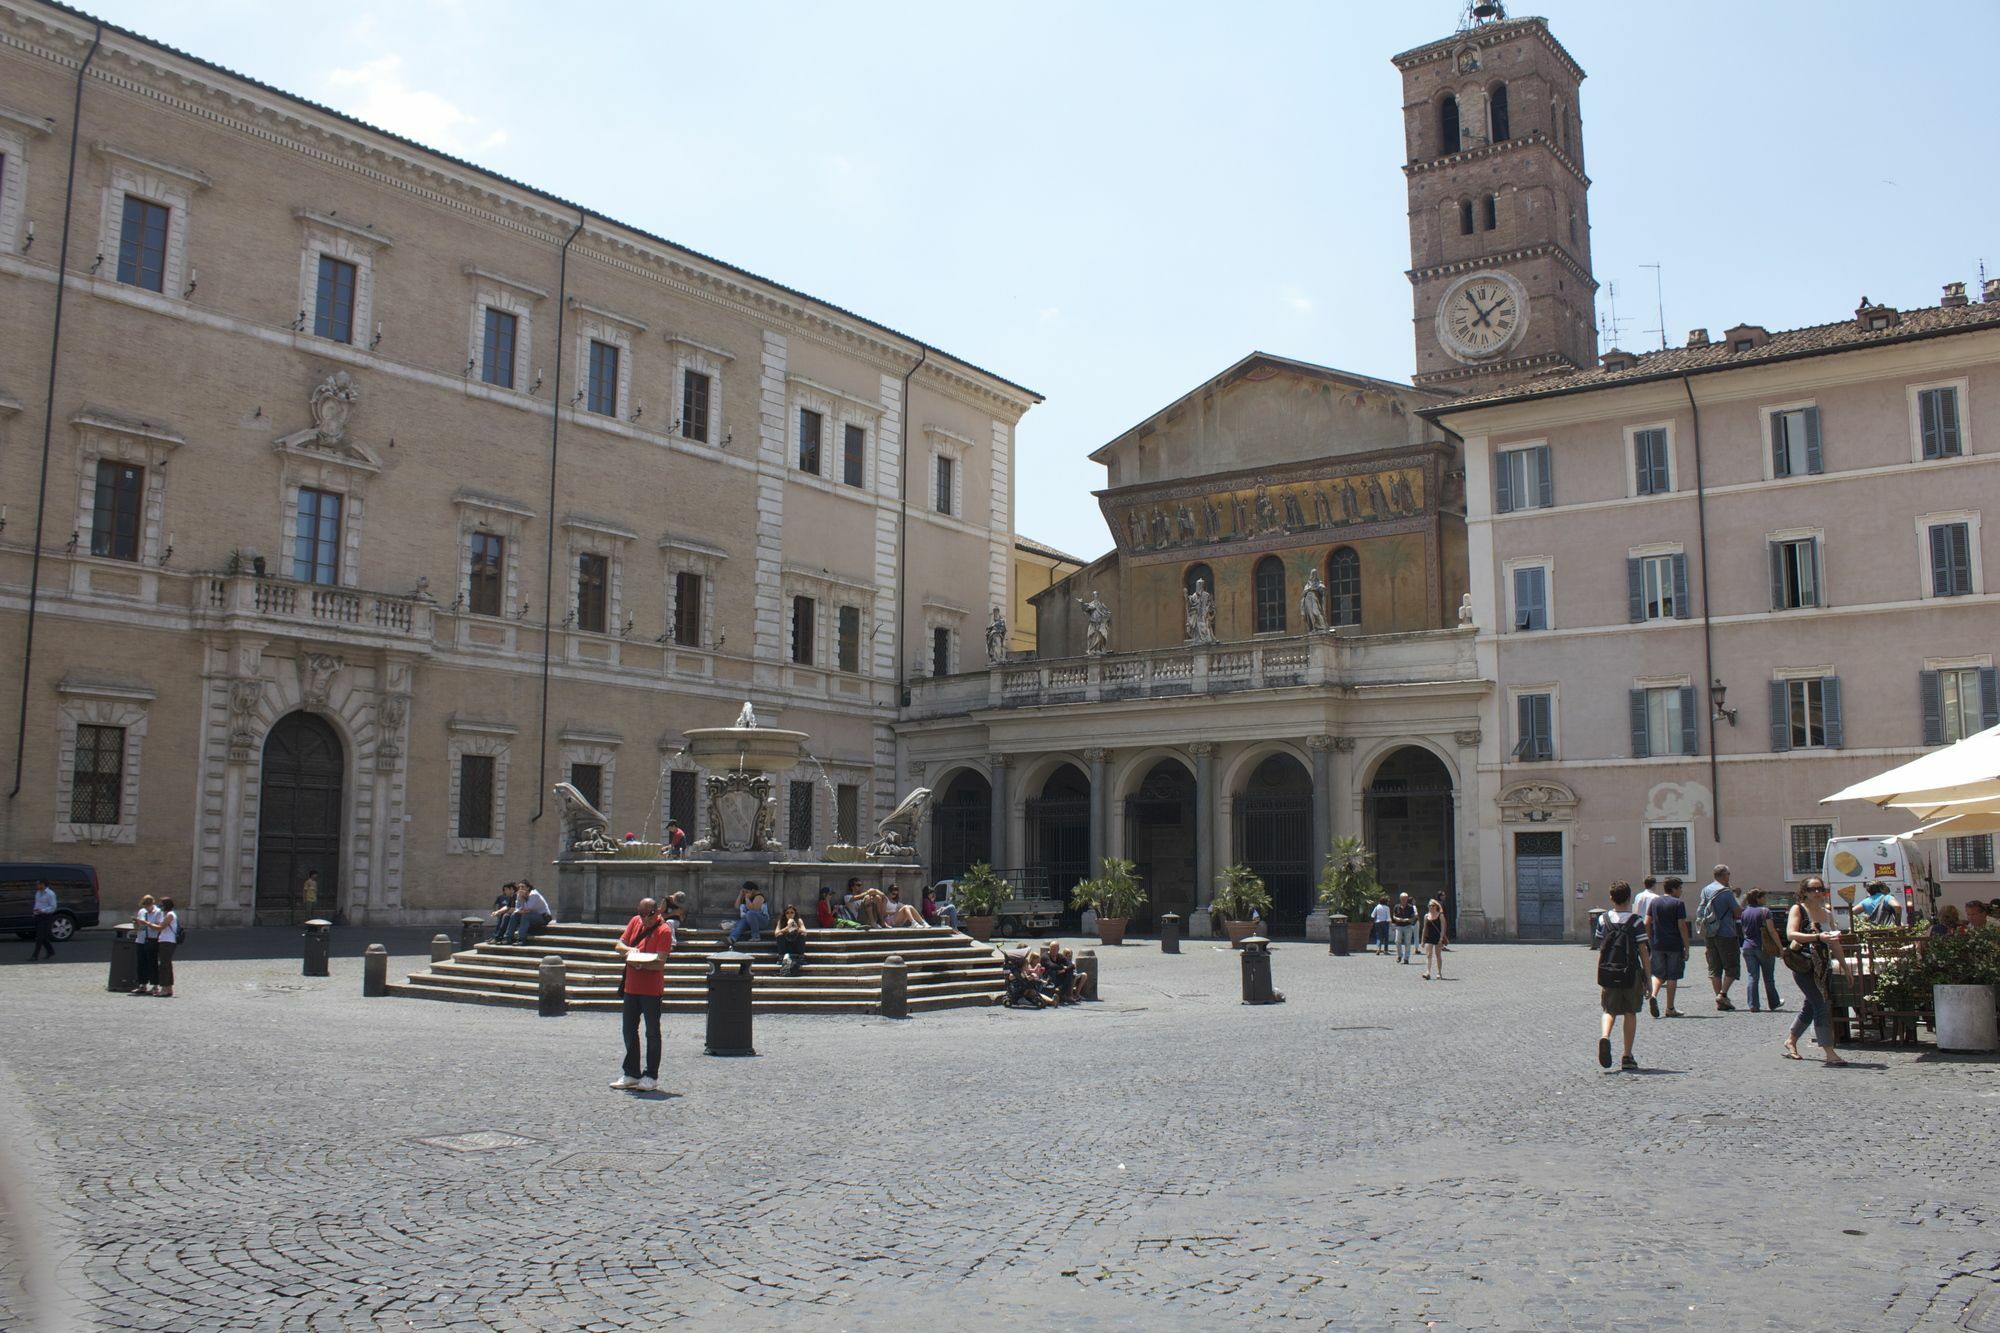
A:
[86,0,2000,556]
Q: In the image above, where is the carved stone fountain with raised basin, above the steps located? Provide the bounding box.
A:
[556,703,930,929]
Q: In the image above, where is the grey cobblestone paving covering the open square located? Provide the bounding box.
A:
[0,933,2000,1331]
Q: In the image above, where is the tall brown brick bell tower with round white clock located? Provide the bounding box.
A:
[1396,2,1598,394]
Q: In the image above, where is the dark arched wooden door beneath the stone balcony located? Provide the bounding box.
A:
[256,713,346,925]
